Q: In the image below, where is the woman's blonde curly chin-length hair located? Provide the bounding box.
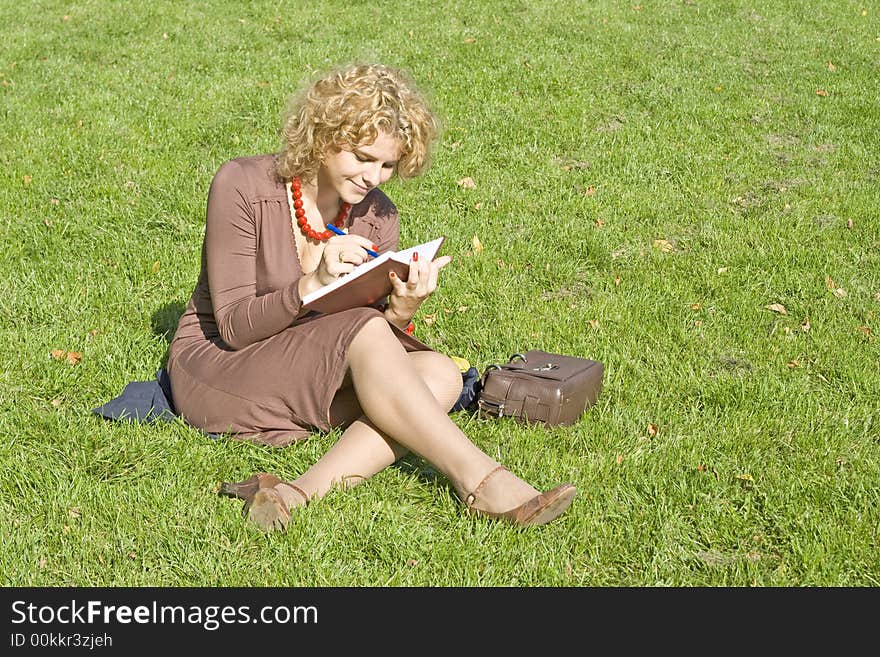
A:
[275,64,439,181]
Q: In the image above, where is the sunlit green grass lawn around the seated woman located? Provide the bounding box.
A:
[0,0,880,586]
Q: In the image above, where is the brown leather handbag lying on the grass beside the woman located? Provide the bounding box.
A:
[477,350,605,426]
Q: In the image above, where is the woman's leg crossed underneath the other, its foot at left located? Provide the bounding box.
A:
[276,352,461,507]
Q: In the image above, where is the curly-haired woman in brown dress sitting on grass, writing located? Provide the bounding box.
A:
[168,65,575,531]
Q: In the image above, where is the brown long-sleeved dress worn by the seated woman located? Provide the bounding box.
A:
[167,155,430,446]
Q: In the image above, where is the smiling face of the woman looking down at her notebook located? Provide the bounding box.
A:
[318,132,400,205]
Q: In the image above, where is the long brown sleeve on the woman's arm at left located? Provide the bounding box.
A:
[204,161,302,350]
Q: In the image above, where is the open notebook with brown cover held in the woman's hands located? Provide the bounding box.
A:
[302,237,446,313]
